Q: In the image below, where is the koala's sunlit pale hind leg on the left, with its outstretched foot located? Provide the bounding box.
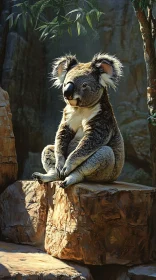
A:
[32,145,59,183]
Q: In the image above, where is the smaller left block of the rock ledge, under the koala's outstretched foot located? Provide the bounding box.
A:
[0,181,47,247]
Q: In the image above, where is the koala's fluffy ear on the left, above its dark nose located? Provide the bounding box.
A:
[51,55,78,87]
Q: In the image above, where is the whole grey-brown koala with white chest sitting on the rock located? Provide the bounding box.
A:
[33,53,124,188]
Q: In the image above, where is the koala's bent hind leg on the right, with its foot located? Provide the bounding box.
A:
[60,146,115,188]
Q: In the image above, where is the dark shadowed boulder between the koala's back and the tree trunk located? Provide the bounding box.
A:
[117,101,152,186]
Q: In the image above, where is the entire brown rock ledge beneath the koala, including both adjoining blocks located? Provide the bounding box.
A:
[0,181,156,265]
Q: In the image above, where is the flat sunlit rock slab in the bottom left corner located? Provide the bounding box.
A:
[0,242,93,280]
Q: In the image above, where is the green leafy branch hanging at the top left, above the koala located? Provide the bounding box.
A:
[7,0,103,40]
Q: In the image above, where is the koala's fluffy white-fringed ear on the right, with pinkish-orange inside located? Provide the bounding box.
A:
[92,53,123,89]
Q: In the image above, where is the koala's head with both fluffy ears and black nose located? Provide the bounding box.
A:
[52,53,122,107]
